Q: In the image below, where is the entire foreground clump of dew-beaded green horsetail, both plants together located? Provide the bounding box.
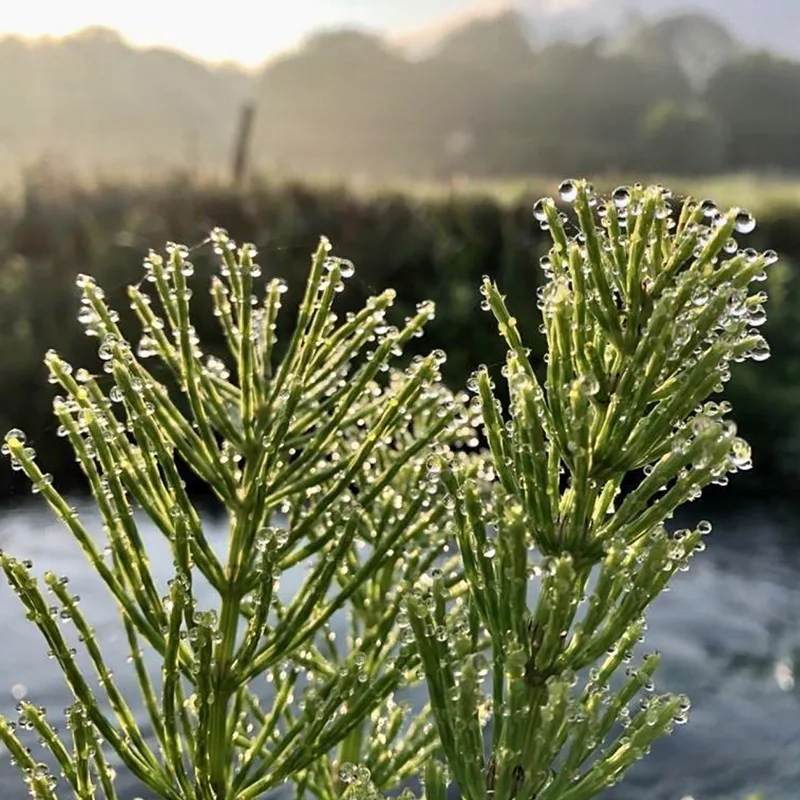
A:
[0,181,775,800]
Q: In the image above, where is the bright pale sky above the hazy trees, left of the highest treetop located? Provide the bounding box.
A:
[0,0,507,66]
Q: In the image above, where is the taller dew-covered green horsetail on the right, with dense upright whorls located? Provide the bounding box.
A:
[407,181,775,800]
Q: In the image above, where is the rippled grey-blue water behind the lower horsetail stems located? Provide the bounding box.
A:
[0,503,800,800]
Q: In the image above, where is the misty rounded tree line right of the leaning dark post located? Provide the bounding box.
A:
[253,12,800,177]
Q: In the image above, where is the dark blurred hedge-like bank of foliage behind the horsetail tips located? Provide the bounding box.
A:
[0,180,800,504]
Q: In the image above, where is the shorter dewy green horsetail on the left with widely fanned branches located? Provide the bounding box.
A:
[0,230,480,800]
